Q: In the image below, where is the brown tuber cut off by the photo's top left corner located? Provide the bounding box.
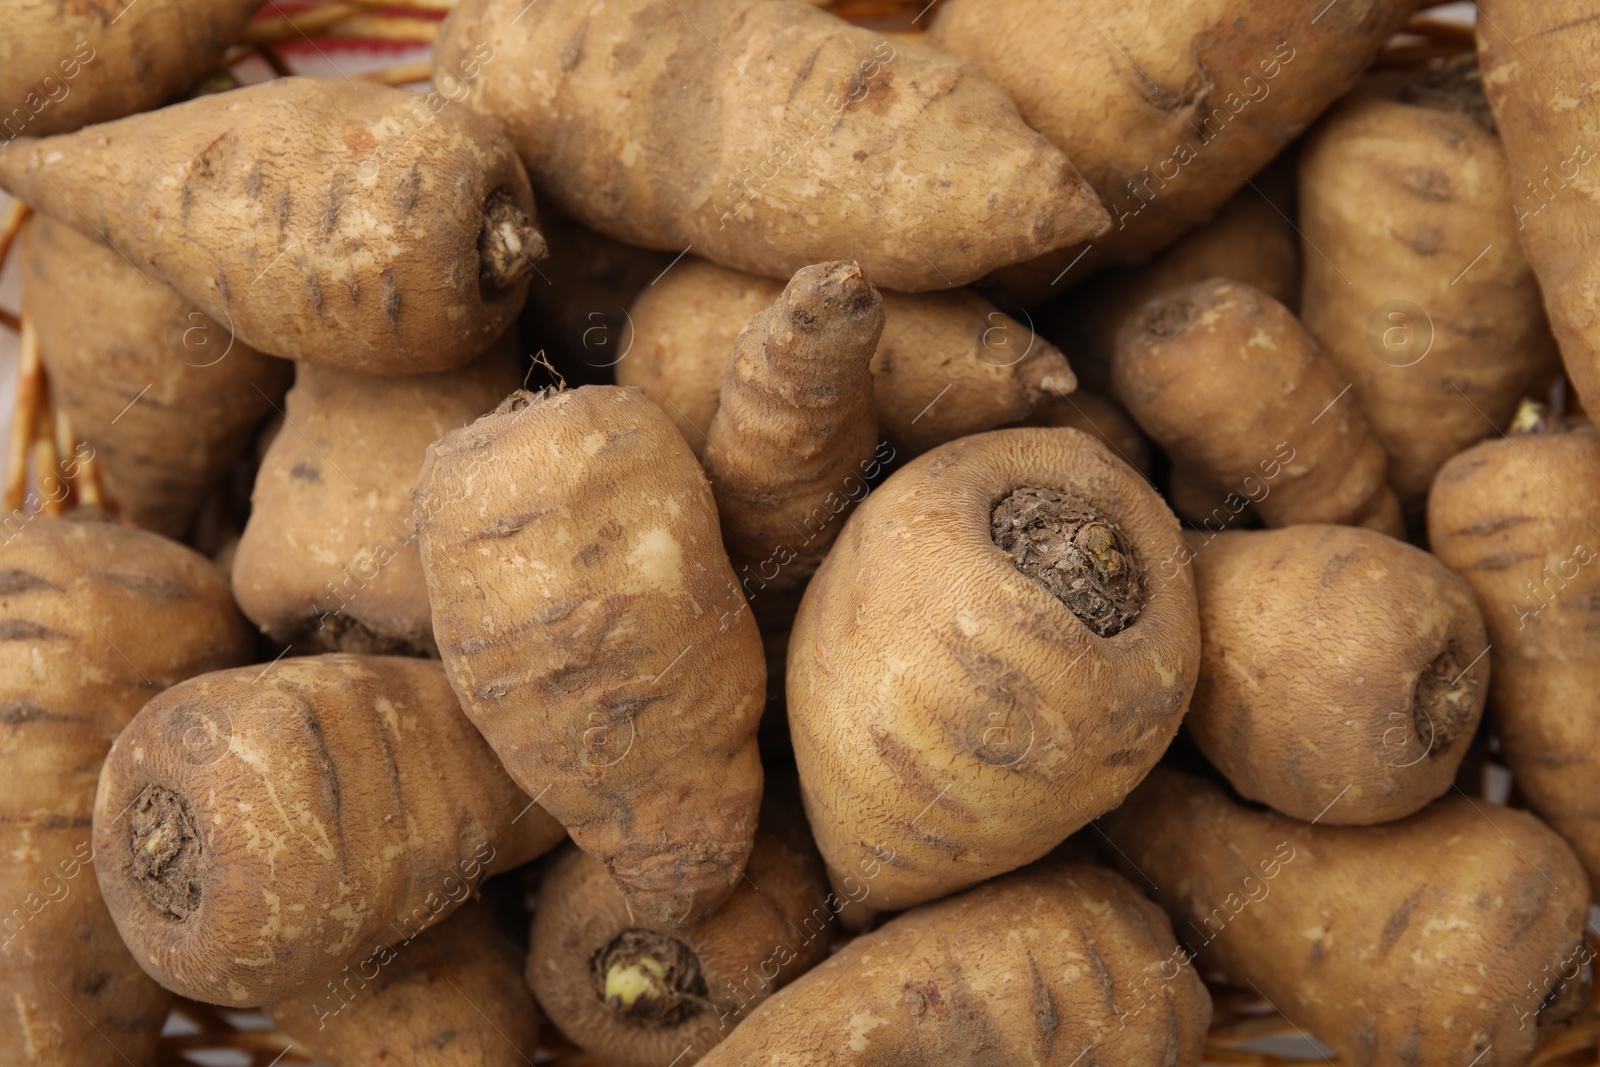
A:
[0,0,261,141]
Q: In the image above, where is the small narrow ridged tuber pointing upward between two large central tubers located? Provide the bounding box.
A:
[702,261,883,593]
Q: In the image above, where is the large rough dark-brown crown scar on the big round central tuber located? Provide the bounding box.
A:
[990,486,1144,637]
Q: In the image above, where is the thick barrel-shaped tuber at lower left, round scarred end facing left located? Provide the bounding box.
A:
[94,654,562,1008]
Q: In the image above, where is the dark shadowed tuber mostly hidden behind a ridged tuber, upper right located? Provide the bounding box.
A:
[1037,187,1301,392]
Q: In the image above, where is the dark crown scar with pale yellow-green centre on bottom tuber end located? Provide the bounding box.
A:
[589,929,710,1025]
